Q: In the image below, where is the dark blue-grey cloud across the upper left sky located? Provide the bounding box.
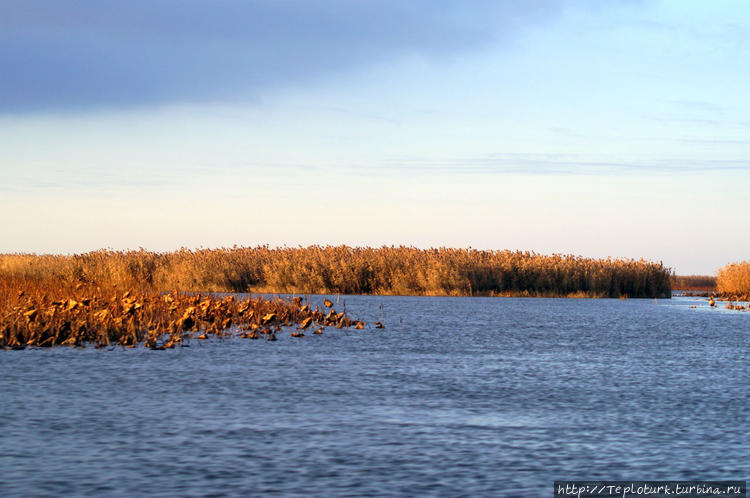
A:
[0,0,559,113]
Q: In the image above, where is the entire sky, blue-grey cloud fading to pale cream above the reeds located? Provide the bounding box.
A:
[0,0,750,274]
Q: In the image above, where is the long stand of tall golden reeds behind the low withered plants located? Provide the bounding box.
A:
[0,246,671,297]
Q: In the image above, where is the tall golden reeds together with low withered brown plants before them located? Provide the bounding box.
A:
[0,246,671,349]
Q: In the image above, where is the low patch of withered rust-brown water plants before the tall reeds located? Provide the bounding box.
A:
[0,277,364,350]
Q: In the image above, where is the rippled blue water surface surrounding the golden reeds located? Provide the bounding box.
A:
[0,296,750,496]
